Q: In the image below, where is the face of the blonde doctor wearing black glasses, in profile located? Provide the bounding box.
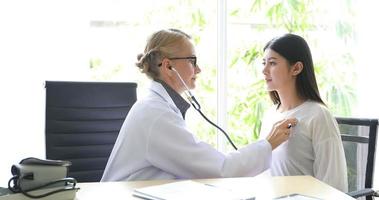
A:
[170,40,201,91]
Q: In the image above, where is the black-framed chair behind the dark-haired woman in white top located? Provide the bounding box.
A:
[336,117,378,200]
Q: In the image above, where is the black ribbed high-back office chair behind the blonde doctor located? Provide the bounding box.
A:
[45,81,137,182]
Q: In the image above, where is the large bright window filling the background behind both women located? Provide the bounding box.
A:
[0,0,379,187]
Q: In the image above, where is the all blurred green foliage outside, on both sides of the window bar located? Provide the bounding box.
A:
[89,0,356,146]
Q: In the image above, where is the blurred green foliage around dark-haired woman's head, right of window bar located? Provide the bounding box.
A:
[228,0,356,145]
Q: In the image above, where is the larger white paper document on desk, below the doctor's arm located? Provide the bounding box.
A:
[133,180,255,200]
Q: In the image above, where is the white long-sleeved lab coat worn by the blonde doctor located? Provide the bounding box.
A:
[101,81,272,181]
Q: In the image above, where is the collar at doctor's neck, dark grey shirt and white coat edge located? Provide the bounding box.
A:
[151,80,190,119]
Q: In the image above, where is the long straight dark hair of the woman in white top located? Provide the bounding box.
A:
[263,33,325,106]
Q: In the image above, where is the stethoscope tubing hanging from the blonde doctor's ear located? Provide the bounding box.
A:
[169,66,238,150]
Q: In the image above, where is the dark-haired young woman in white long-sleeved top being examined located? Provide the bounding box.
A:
[260,34,348,192]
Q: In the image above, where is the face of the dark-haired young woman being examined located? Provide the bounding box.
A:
[262,49,295,93]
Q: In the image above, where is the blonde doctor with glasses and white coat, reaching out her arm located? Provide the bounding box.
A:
[101,29,297,181]
